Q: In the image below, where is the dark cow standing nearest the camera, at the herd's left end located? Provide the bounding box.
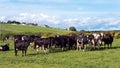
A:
[14,36,30,56]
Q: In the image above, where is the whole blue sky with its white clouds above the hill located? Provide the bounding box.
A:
[0,0,120,30]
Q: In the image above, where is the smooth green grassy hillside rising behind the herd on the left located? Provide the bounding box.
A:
[0,24,70,34]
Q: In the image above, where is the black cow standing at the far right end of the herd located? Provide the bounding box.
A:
[102,32,114,47]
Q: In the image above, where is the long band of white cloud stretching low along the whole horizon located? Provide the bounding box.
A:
[0,13,120,30]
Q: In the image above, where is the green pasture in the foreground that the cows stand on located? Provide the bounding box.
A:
[0,39,120,68]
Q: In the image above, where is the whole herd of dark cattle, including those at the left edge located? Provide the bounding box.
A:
[0,33,113,56]
